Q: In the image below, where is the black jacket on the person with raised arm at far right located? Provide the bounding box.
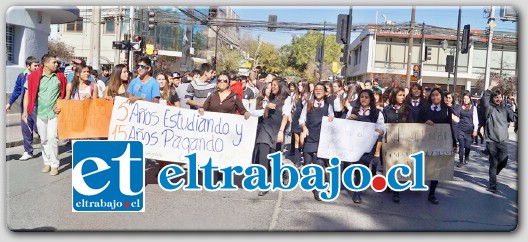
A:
[480,90,516,142]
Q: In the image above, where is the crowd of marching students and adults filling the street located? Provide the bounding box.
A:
[6,54,517,204]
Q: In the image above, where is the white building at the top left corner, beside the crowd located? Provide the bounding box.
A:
[5,6,79,93]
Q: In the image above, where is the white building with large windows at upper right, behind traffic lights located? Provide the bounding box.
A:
[347,25,518,93]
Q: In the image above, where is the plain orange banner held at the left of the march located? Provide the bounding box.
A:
[57,99,113,139]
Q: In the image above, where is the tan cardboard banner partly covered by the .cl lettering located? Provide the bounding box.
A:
[382,123,454,181]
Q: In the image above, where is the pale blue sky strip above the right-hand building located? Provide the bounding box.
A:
[232,6,517,47]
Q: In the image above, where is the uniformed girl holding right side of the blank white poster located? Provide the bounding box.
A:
[344,89,387,203]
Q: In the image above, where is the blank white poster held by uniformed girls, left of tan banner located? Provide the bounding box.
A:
[317,117,379,162]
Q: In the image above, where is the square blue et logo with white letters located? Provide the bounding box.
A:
[72,140,145,212]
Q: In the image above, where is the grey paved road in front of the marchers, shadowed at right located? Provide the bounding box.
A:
[6,136,518,231]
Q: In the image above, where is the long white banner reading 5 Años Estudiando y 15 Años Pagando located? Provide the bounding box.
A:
[108,97,258,168]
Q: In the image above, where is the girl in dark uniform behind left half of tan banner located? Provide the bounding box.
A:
[384,87,409,203]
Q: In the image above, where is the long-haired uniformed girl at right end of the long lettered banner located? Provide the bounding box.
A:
[255,78,291,196]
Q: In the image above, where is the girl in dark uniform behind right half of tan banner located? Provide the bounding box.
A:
[411,88,457,204]
